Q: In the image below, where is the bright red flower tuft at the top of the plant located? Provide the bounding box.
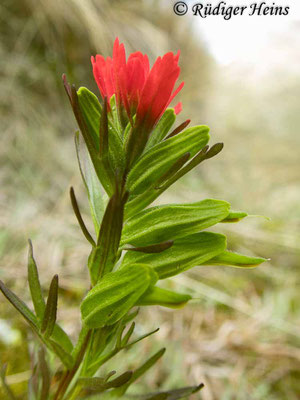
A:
[91,38,183,132]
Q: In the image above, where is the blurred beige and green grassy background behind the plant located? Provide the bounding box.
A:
[0,0,300,400]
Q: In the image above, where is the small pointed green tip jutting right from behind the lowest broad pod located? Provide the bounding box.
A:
[137,286,192,308]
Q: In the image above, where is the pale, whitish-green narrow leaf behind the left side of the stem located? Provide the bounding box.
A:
[75,132,105,235]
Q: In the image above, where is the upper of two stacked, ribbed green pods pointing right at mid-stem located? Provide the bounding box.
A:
[121,199,230,246]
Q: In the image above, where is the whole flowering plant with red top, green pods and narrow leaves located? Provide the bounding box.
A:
[0,39,264,400]
